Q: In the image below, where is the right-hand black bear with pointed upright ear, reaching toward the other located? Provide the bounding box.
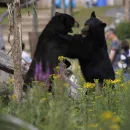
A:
[59,12,115,83]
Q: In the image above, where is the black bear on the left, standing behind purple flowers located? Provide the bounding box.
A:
[23,12,79,91]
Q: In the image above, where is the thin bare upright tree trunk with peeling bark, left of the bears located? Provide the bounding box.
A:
[12,0,23,100]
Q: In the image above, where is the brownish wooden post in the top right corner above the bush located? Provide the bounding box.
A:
[125,0,130,21]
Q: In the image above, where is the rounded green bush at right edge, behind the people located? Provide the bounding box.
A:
[116,22,130,40]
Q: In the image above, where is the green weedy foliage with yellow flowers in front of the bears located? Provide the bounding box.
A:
[0,67,130,130]
